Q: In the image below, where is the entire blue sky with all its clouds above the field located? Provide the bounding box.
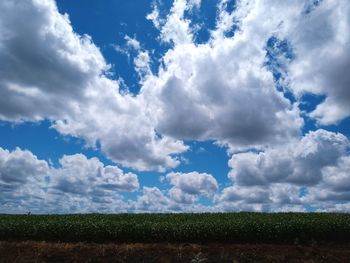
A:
[0,0,350,214]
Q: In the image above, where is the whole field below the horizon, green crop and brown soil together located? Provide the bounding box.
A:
[0,213,350,262]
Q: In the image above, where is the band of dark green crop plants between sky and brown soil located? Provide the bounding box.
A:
[0,213,350,244]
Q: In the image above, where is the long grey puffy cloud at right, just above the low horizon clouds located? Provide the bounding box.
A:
[229,130,349,186]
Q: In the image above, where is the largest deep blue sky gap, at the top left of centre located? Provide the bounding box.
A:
[57,0,171,93]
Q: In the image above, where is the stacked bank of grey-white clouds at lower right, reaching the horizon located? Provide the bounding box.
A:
[215,130,350,211]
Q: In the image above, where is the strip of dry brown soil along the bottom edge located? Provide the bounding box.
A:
[0,241,350,263]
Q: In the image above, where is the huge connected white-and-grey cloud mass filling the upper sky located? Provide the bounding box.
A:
[0,0,349,171]
